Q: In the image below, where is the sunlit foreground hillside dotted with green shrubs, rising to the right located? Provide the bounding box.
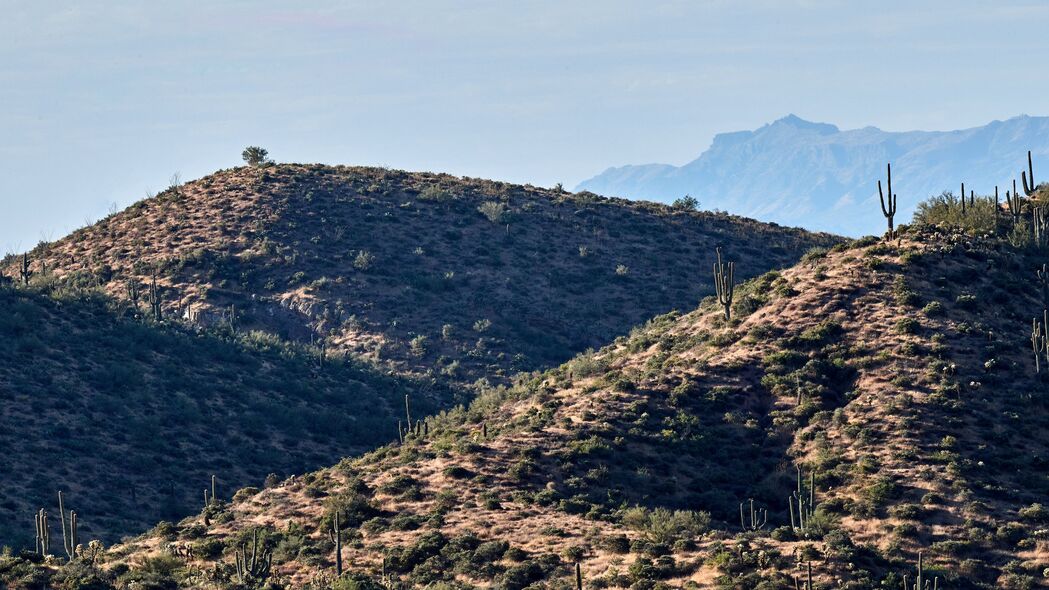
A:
[26,222,1049,589]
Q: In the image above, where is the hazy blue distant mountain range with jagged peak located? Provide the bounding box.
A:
[577,114,1049,236]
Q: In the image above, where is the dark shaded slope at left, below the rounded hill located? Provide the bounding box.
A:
[0,287,462,547]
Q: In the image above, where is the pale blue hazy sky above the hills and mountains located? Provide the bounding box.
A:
[0,0,1049,252]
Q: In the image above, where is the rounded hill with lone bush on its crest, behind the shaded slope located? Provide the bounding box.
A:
[5,165,836,383]
